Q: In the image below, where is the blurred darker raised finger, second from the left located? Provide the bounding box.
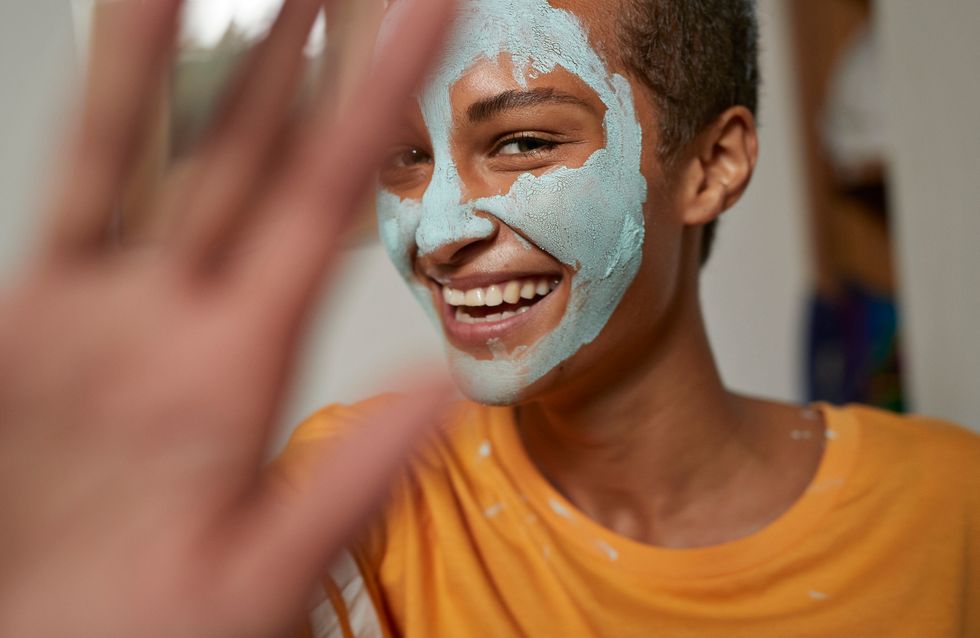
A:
[162,0,324,268]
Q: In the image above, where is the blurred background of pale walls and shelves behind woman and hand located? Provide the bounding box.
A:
[0,0,980,440]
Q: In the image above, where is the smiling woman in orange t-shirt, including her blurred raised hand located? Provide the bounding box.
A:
[0,0,980,638]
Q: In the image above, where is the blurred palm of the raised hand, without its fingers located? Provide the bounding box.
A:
[0,265,310,636]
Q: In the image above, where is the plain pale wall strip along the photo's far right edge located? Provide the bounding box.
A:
[878,0,980,431]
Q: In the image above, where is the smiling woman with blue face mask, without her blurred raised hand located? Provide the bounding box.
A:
[280,0,980,638]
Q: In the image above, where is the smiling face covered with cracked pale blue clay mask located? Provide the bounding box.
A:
[378,0,668,404]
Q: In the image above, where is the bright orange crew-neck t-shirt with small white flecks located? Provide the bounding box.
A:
[283,404,980,638]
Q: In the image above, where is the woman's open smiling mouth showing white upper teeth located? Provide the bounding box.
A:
[436,275,562,347]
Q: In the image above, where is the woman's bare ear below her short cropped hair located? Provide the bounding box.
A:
[679,106,759,226]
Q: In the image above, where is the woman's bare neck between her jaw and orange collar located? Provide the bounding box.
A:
[517,272,819,546]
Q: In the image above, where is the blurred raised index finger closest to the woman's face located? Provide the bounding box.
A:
[238,0,454,318]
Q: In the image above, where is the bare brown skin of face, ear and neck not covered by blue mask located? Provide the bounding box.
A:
[382,0,823,548]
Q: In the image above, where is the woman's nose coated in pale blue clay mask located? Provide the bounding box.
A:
[415,163,499,265]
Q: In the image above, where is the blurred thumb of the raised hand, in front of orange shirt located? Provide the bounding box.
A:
[225,381,452,628]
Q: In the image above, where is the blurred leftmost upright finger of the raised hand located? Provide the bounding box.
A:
[42,0,182,262]
